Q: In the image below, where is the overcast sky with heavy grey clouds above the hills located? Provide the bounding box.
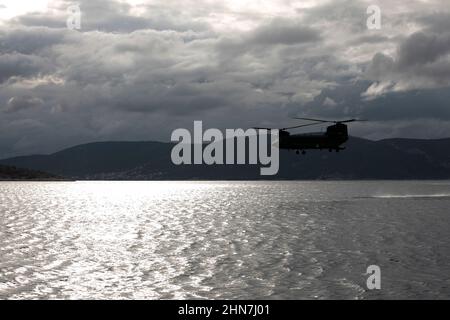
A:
[0,0,450,158]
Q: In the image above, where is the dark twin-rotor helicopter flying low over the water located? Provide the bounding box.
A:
[255,118,367,154]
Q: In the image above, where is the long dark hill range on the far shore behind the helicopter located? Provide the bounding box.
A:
[0,137,450,180]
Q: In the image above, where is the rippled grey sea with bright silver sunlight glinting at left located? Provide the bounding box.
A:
[0,181,450,300]
